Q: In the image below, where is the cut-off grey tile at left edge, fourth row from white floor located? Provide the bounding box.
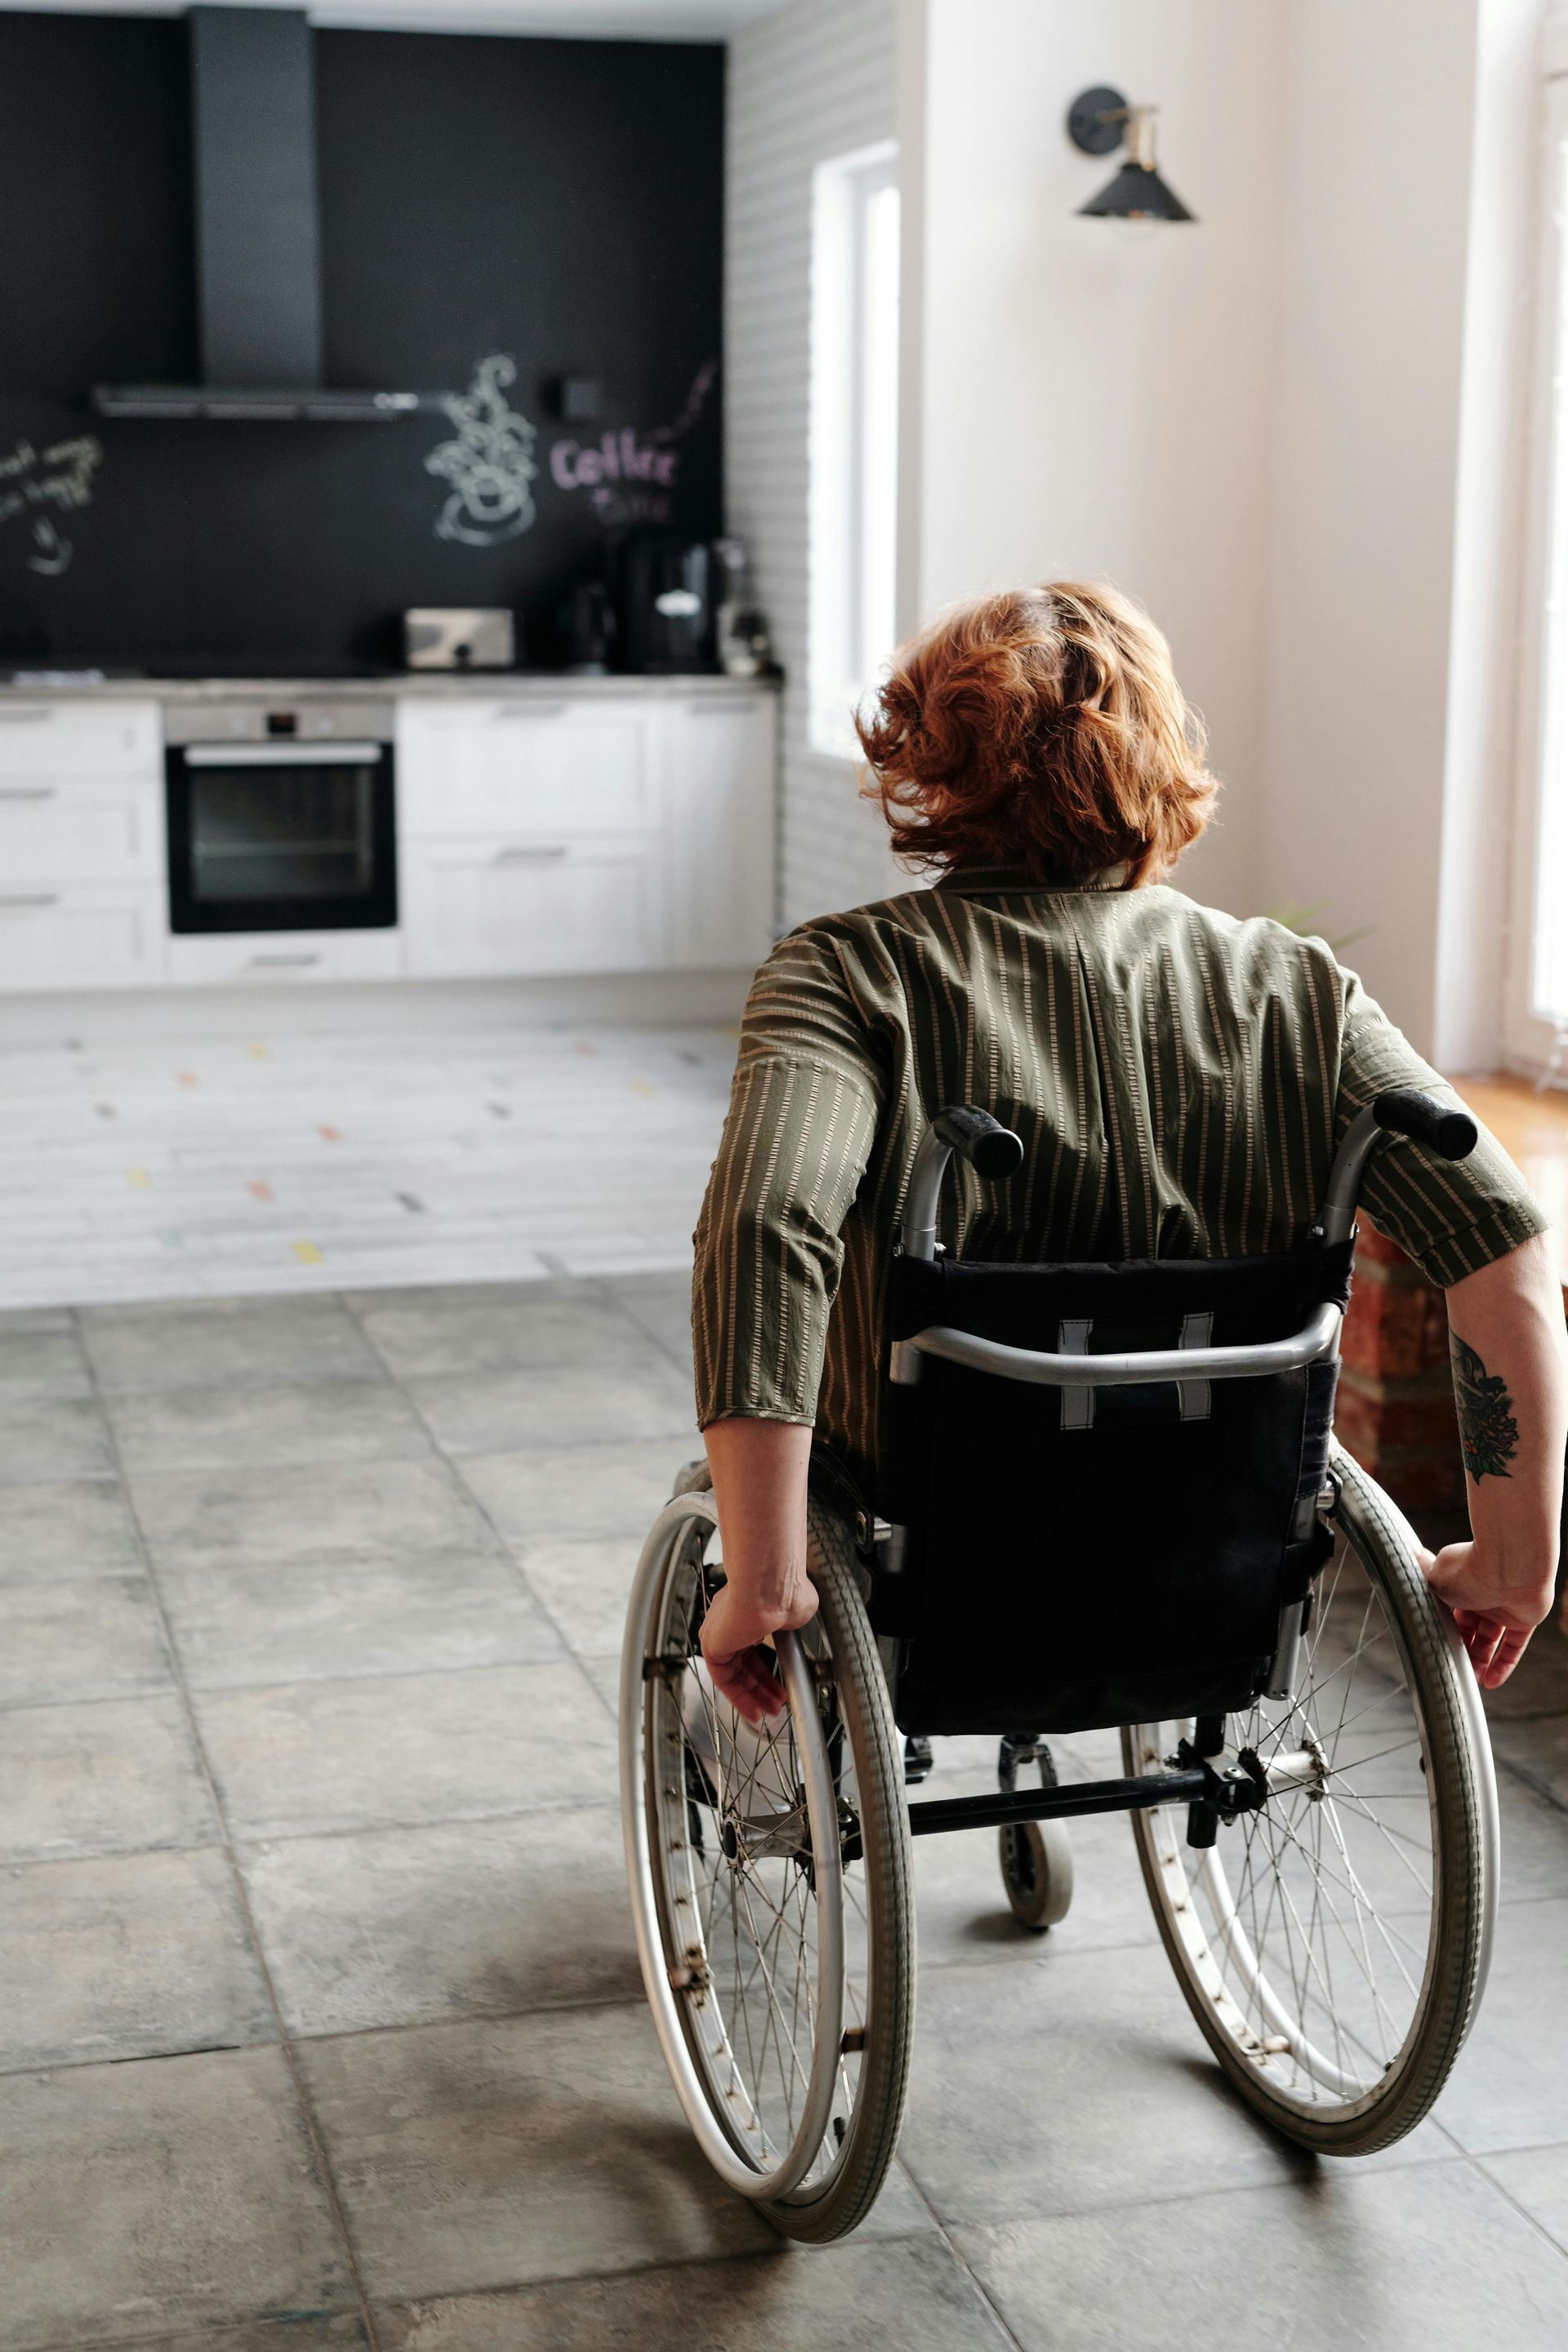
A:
[0,1576,169,1708]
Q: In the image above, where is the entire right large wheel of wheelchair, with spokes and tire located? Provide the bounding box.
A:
[1121,1451,1498,2157]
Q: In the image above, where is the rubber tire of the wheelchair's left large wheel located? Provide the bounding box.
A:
[757,1496,915,2246]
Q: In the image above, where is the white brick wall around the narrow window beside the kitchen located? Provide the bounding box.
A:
[724,0,907,927]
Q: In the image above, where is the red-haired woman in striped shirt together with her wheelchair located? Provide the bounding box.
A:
[621,583,1568,2239]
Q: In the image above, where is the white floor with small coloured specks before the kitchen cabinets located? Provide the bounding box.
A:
[0,990,736,1316]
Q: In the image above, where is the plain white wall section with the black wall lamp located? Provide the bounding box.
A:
[900,0,1284,912]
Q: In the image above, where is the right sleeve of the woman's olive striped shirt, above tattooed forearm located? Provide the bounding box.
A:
[1333,971,1547,1289]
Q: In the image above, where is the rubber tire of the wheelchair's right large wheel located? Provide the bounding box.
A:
[1121,1451,1498,2157]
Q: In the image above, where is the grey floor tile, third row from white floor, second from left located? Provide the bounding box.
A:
[129,1454,492,1564]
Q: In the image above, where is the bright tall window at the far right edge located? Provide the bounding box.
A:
[1507,23,1568,1075]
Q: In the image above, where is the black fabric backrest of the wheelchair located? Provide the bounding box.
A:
[872,1245,1349,1734]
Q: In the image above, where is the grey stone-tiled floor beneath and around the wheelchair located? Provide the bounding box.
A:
[0,1275,1568,2352]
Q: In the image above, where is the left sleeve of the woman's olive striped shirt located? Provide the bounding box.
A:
[691,927,884,1428]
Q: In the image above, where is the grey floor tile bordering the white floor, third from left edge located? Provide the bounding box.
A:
[359,1284,644,1381]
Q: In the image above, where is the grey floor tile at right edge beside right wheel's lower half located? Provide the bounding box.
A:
[1437,1898,1568,2154]
